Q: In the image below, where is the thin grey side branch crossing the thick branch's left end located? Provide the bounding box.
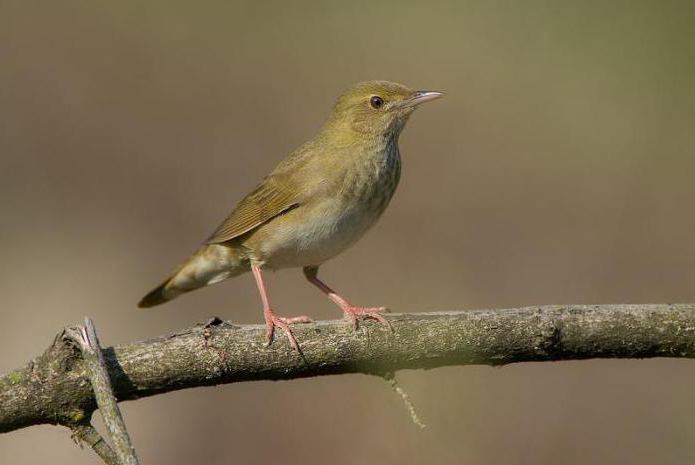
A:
[69,318,138,465]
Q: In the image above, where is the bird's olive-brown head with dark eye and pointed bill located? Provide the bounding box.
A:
[328,81,444,141]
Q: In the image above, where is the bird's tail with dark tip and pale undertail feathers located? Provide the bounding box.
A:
[138,244,249,308]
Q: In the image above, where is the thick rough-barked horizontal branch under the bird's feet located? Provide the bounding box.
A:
[0,304,695,433]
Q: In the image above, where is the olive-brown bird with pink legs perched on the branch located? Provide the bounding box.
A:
[138,81,444,351]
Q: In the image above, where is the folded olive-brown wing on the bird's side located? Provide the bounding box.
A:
[207,176,299,244]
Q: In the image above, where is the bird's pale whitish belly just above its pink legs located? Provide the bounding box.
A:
[249,201,381,269]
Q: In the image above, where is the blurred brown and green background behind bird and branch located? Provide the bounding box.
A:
[0,0,695,465]
